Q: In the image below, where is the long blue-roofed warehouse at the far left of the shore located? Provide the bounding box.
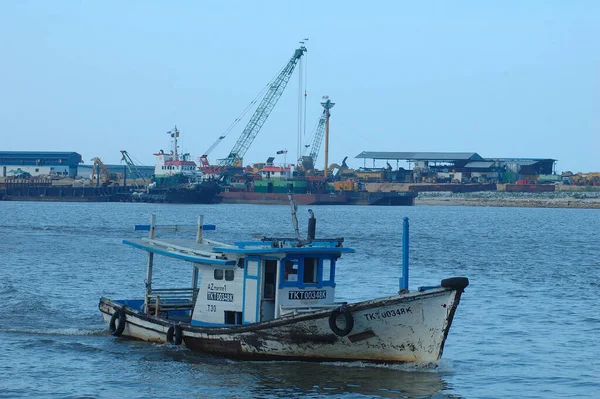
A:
[0,151,83,177]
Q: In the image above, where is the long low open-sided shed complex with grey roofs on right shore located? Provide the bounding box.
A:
[356,151,556,183]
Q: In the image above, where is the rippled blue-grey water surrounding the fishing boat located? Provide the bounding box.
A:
[0,202,600,398]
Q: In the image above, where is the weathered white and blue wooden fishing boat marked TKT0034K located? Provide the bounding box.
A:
[99,195,469,363]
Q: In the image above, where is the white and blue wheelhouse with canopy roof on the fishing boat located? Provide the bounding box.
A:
[123,217,346,327]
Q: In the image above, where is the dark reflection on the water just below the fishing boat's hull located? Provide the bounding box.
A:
[165,351,450,398]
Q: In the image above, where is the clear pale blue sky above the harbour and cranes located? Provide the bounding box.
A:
[0,0,600,172]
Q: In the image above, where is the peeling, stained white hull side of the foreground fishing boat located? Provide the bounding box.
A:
[100,288,462,363]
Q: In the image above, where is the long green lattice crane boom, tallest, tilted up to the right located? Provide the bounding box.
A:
[219,46,306,167]
